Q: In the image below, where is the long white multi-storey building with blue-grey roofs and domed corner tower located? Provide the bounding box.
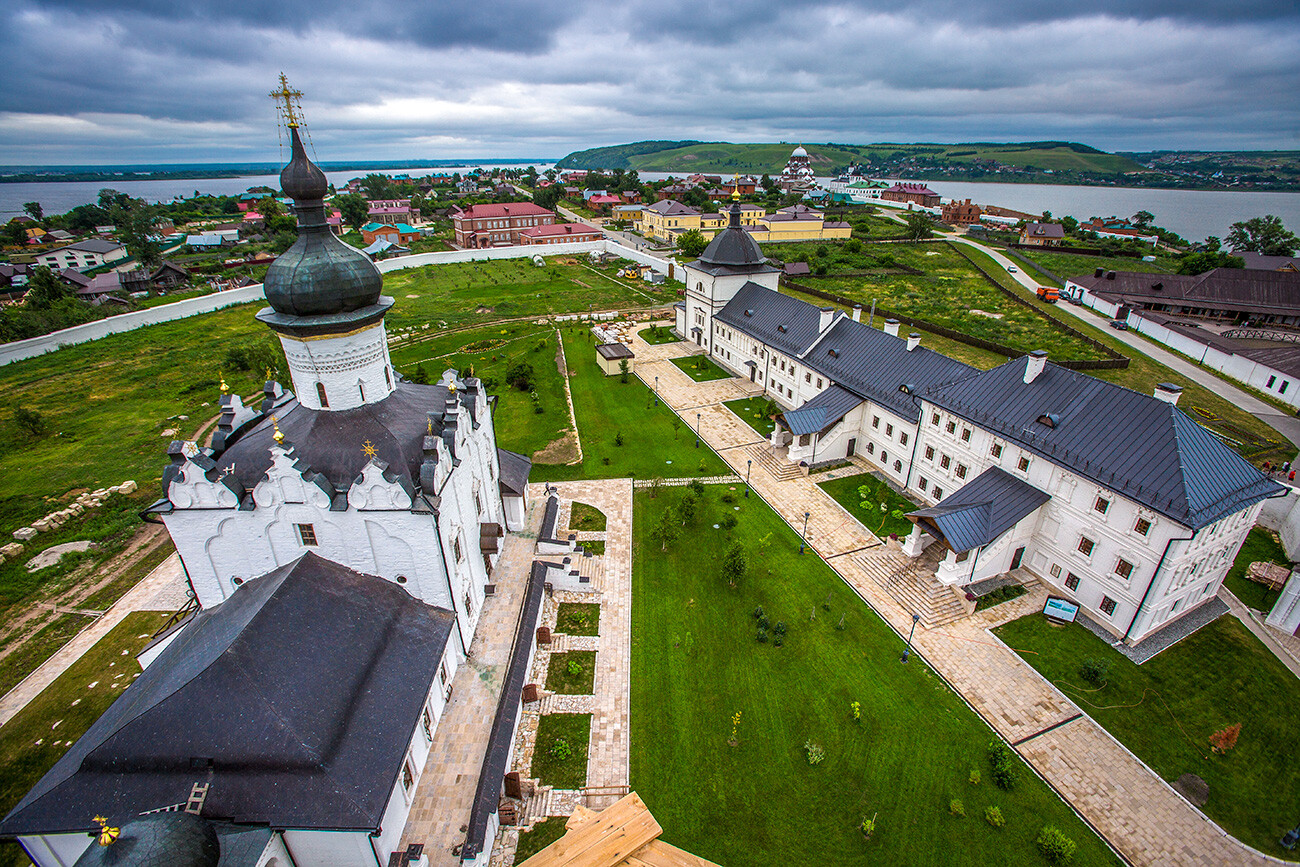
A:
[676,207,1286,643]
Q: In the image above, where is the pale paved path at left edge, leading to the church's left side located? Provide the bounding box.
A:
[0,554,189,725]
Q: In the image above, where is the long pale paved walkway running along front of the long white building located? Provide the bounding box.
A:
[637,353,1282,867]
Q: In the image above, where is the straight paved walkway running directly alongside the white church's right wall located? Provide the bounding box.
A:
[400,485,546,867]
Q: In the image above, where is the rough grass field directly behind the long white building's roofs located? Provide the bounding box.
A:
[774,243,1104,359]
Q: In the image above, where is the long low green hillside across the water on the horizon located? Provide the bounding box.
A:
[559,142,1145,177]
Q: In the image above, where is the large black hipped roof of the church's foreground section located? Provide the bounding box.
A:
[0,554,454,836]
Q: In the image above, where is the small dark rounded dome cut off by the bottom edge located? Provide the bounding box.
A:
[74,812,221,867]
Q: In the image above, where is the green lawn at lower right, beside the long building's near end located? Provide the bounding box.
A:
[996,614,1300,859]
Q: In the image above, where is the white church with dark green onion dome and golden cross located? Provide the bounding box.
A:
[0,103,541,867]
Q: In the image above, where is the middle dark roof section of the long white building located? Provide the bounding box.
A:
[801,317,978,421]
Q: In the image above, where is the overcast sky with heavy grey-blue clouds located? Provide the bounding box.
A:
[0,0,1300,165]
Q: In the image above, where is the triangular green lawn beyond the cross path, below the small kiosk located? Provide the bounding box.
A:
[527,328,728,481]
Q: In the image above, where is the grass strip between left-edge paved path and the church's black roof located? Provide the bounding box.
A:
[0,611,169,867]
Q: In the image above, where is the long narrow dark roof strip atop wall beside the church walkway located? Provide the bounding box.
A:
[460,560,547,862]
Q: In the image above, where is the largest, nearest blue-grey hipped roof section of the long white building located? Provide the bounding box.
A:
[924,357,1286,529]
